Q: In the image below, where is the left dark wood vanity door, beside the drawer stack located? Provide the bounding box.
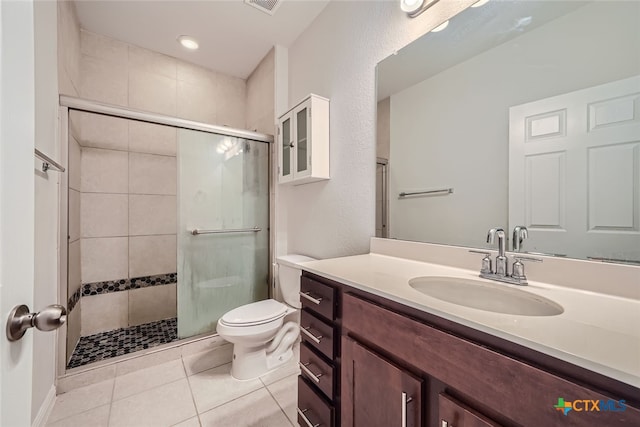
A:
[341,337,422,427]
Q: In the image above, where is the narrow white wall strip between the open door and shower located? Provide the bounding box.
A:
[29,1,59,421]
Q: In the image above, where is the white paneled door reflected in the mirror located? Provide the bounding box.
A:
[509,76,640,261]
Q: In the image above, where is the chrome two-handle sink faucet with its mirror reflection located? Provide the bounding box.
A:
[469,226,542,285]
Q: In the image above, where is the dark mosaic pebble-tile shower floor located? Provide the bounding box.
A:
[67,317,178,369]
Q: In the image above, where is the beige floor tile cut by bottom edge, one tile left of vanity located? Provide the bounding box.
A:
[200,389,291,427]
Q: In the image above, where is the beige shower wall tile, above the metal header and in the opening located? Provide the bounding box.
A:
[58,1,275,362]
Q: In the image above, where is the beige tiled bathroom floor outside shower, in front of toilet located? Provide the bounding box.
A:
[47,349,299,427]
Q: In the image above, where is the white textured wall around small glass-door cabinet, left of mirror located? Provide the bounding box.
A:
[276,0,473,258]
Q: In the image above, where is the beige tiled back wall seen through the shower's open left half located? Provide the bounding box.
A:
[70,111,177,336]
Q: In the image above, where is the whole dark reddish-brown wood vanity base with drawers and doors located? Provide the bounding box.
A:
[298,272,640,427]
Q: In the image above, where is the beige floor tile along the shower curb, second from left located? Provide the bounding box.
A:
[113,360,186,401]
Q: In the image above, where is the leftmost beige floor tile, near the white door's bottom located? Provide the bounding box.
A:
[48,379,114,423]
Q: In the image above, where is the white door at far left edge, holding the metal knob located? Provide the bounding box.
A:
[0,1,36,427]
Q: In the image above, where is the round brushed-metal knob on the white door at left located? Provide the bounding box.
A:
[7,304,67,341]
